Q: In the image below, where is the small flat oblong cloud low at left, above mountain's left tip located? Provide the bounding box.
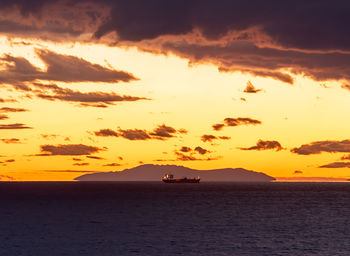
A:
[39,144,103,156]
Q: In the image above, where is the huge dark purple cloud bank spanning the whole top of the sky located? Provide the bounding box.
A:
[0,0,350,83]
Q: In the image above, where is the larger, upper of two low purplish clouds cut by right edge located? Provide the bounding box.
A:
[291,140,350,155]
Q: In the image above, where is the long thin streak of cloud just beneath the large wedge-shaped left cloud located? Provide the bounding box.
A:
[33,83,148,107]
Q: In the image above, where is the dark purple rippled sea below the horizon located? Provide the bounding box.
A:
[0,182,350,256]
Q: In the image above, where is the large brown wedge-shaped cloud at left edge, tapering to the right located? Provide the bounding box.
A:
[0,50,137,86]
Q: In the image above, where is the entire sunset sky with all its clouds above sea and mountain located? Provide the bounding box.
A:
[0,0,350,181]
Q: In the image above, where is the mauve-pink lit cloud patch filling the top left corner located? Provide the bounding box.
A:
[0,0,108,41]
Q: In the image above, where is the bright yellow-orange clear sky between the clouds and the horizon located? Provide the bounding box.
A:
[0,37,350,181]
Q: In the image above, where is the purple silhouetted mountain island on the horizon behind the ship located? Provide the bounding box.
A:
[75,164,275,182]
